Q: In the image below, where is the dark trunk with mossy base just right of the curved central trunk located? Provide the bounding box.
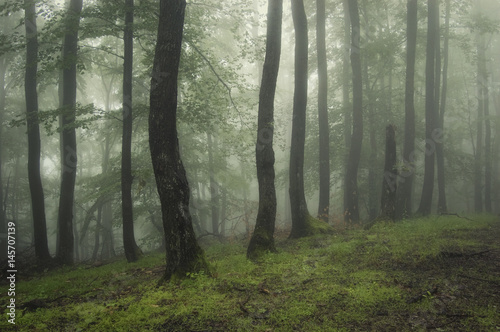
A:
[289,0,309,238]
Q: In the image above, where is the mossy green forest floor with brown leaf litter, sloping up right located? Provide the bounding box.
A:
[0,216,500,331]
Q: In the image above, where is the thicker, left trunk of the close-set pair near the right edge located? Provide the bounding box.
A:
[418,0,438,216]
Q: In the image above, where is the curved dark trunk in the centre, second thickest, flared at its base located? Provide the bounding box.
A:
[247,0,283,259]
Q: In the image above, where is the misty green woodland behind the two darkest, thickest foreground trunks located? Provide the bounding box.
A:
[0,0,500,264]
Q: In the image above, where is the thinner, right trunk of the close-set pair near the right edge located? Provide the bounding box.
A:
[436,0,450,213]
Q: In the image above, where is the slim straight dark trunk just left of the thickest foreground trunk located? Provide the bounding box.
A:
[121,0,140,262]
